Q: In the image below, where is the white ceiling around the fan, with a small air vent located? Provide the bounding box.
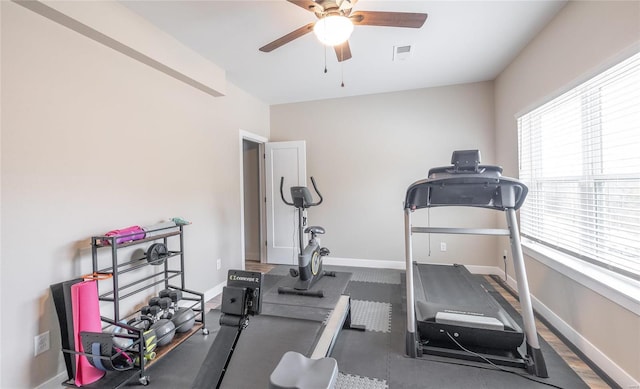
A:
[121,0,566,104]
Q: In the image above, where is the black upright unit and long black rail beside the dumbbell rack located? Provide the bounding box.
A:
[192,270,263,389]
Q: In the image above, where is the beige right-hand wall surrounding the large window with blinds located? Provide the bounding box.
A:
[495,1,640,382]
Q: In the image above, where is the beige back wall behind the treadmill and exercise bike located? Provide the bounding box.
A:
[271,82,495,265]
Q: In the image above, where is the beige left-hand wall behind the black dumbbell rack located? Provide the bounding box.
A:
[0,1,269,388]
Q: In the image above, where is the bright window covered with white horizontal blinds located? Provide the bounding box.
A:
[518,53,640,280]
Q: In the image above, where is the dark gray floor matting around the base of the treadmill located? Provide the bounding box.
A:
[332,270,587,389]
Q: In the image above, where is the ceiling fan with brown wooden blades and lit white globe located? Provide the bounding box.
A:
[259,0,427,62]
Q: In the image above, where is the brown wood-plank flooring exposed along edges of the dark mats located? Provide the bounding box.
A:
[207,261,611,389]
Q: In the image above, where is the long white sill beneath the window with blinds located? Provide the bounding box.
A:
[522,238,640,316]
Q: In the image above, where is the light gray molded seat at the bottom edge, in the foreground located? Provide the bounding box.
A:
[269,351,338,389]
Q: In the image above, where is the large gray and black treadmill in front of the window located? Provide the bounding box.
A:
[404,150,548,378]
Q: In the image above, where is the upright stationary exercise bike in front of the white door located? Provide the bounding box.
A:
[278,177,336,297]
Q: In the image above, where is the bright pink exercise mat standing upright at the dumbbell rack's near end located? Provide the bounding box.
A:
[71,280,105,386]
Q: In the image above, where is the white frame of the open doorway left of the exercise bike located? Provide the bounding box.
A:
[238,129,268,270]
